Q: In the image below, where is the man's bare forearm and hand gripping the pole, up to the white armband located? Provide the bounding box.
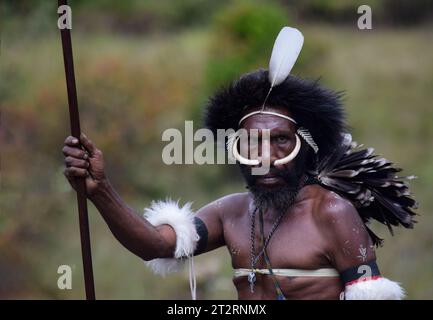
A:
[63,135,176,260]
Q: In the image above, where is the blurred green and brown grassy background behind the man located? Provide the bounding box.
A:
[0,0,433,299]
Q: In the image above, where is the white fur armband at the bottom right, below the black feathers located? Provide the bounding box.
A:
[344,277,405,300]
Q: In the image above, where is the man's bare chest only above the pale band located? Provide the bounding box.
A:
[224,210,330,269]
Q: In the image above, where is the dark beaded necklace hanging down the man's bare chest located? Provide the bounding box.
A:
[248,175,308,293]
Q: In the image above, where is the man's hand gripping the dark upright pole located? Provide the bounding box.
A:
[62,134,106,196]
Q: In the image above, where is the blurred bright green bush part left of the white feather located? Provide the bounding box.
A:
[206,1,290,90]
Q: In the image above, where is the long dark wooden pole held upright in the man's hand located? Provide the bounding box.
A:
[58,0,95,300]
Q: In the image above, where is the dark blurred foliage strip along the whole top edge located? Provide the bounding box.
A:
[4,0,433,33]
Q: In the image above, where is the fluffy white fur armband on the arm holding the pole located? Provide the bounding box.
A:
[144,199,199,275]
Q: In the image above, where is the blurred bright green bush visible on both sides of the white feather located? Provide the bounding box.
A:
[202,1,328,93]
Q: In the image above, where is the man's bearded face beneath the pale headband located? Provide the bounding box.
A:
[241,107,306,210]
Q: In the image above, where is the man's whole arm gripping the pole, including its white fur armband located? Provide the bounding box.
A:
[62,135,224,260]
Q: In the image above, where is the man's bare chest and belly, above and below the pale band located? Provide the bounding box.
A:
[224,206,341,299]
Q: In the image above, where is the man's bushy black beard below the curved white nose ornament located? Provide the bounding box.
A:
[240,156,307,213]
